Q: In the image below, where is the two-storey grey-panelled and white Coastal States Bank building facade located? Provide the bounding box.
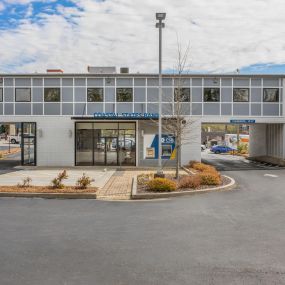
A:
[0,73,285,166]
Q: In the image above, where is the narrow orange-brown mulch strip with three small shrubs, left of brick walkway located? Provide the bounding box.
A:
[0,186,97,194]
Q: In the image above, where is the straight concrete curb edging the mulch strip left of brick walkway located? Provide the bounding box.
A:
[0,192,96,199]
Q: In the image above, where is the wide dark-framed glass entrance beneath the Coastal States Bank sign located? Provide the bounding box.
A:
[75,122,136,166]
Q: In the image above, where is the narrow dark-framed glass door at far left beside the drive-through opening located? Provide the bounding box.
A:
[21,123,36,165]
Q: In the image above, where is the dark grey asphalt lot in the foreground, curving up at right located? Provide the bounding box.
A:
[0,170,285,285]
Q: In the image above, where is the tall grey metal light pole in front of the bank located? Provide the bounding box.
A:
[155,13,166,175]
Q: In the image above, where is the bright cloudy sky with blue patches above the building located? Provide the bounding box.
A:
[0,0,285,74]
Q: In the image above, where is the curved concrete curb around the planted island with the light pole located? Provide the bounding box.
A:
[132,175,236,200]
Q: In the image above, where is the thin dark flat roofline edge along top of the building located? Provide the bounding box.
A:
[0,73,285,78]
